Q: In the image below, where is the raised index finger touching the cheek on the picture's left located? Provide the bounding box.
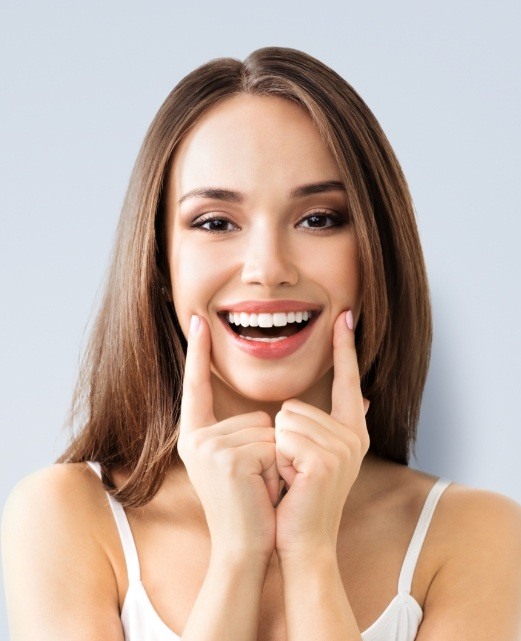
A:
[179,315,215,430]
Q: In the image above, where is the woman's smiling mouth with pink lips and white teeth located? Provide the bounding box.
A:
[219,303,320,358]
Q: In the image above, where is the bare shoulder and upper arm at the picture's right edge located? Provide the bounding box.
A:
[416,488,521,641]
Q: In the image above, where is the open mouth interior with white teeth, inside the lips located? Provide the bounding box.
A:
[220,311,319,343]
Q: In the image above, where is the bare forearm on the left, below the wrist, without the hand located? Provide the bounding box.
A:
[182,554,268,641]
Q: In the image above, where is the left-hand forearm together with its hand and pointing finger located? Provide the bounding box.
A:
[178,319,279,641]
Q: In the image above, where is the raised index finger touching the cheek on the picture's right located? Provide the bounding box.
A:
[331,311,365,435]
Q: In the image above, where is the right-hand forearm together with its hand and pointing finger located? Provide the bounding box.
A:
[275,314,369,641]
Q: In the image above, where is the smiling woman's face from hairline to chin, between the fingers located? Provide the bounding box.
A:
[167,94,359,401]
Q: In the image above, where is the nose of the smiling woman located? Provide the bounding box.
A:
[241,229,298,288]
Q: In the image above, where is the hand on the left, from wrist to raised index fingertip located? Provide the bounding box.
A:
[178,316,279,560]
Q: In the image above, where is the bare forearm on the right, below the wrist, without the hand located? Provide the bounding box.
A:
[279,551,361,641]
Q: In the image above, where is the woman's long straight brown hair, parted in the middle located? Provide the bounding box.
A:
[59,47,432,506]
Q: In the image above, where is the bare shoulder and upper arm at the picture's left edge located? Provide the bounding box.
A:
[2,466,123,641]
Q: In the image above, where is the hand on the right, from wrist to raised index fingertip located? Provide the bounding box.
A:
[275,313,369,556]
